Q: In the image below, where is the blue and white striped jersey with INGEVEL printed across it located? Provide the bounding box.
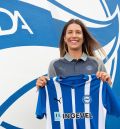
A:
[36,74,120,129]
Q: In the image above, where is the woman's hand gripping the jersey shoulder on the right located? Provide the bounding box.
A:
[96,71,112,85]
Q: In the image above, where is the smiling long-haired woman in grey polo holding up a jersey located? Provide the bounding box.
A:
[36,19,112,87]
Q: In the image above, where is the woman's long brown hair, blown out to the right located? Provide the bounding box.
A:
[59,19,105,57]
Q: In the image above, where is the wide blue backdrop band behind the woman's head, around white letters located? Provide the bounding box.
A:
[0,0,118,49]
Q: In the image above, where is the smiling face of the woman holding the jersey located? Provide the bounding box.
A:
[64,23,84,51]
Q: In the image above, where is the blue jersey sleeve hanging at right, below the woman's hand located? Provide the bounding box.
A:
[103,83,120,117]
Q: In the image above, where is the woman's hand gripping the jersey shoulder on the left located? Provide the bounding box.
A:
[36,76,49,89]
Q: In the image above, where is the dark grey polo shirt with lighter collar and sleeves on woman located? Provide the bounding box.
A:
[48,53,106,77]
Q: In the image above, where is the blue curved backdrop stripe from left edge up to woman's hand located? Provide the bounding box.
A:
[0,79,36,116]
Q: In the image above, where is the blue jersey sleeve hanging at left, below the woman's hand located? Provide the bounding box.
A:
[36,87,46,119]
